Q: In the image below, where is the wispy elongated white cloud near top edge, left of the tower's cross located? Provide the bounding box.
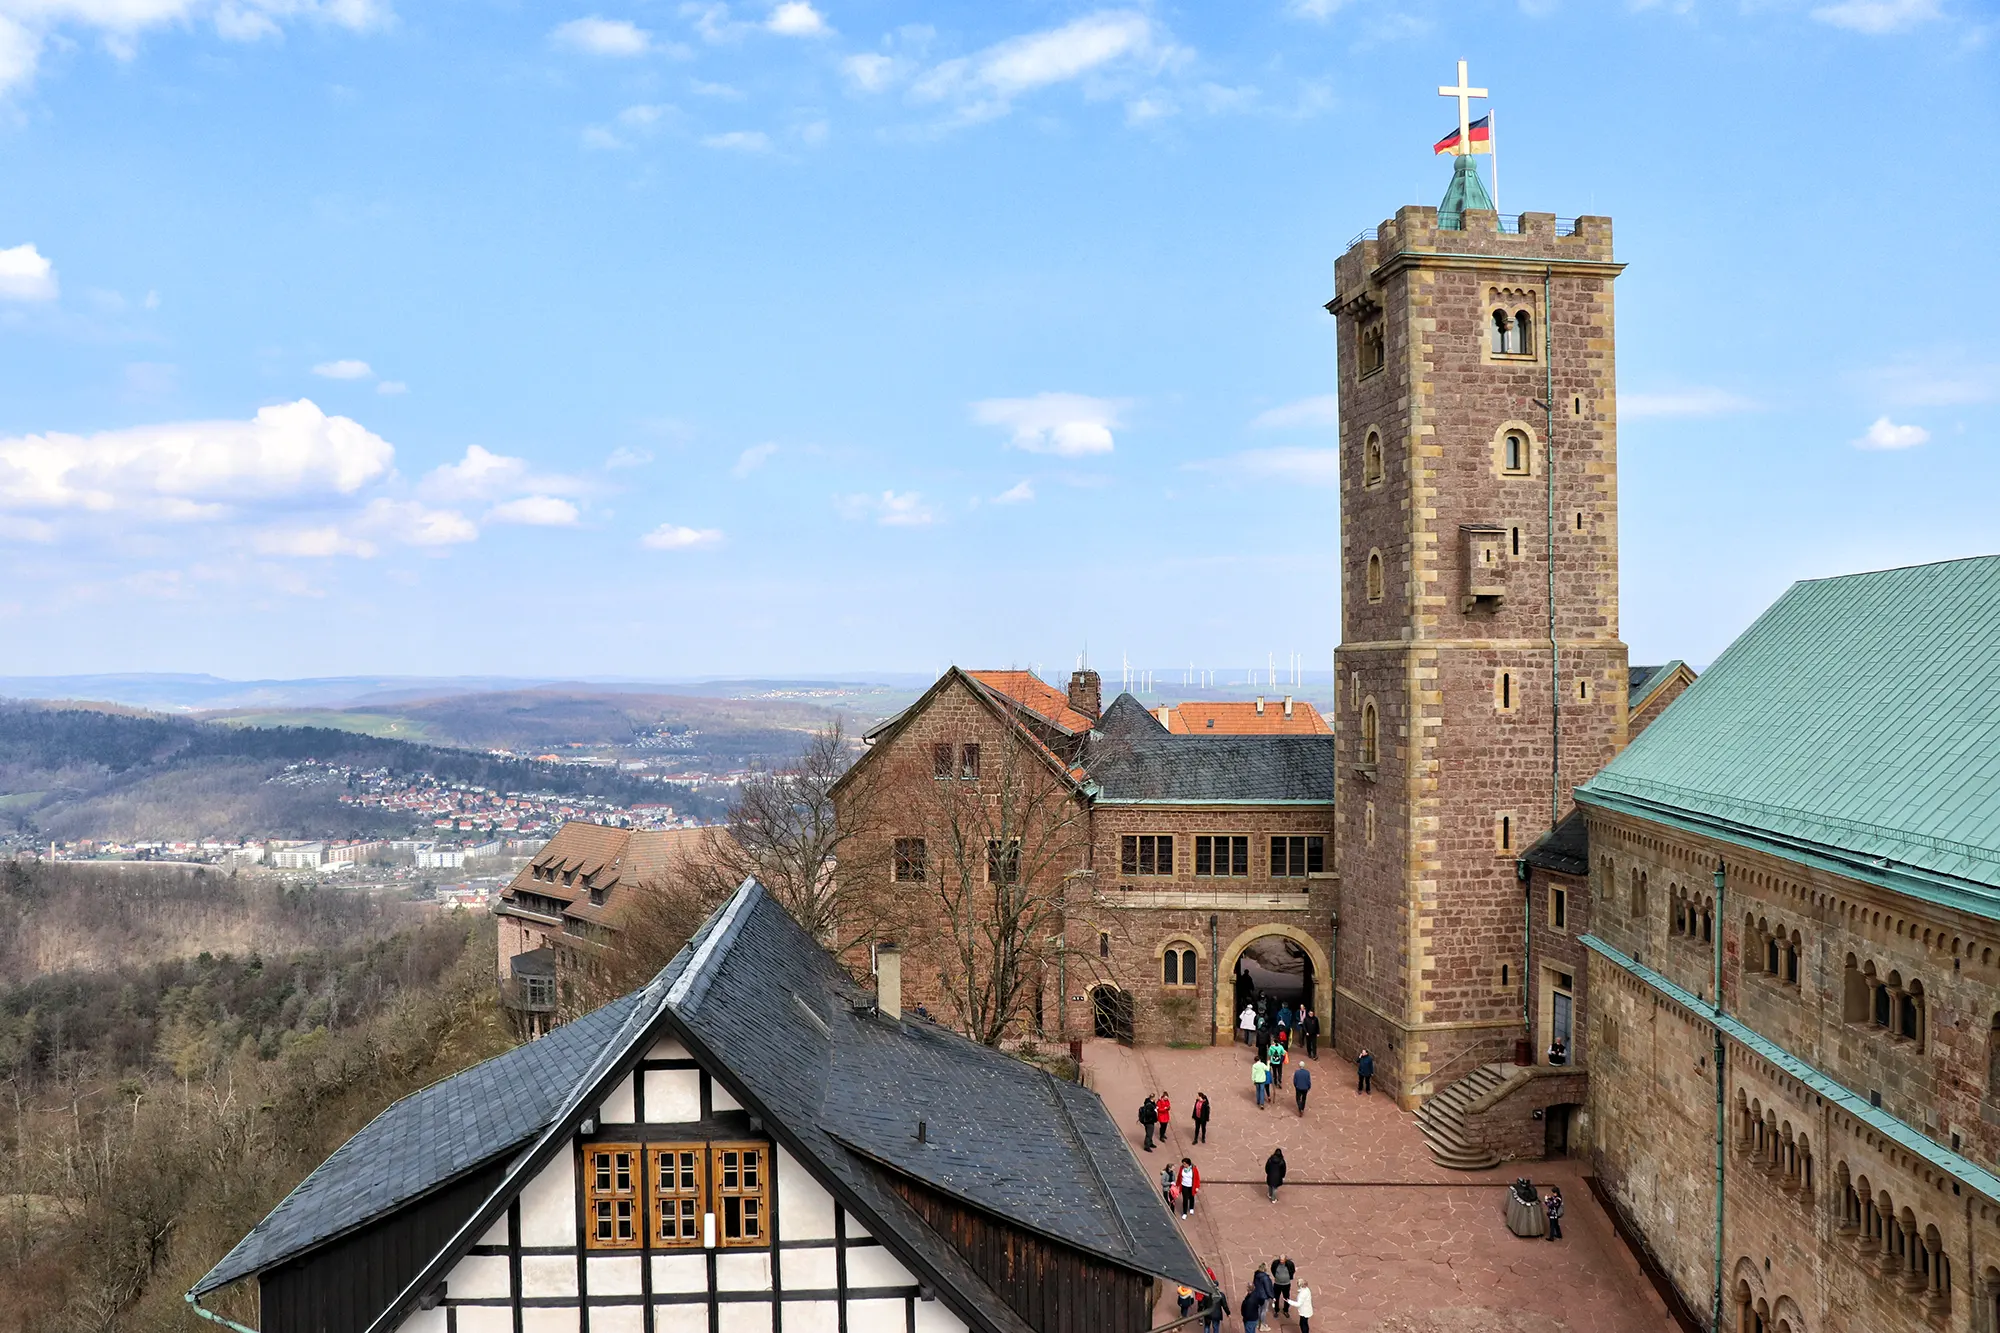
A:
[912,10,1186,120]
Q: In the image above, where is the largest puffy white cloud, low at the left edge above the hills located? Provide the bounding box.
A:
[0,398,396,518]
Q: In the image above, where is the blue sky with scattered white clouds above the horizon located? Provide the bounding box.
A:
[0,0,2000,687]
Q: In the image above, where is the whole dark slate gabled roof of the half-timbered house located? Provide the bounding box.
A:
[190,881,1208,1333]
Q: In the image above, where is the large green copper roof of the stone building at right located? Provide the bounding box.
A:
[1576,556,2000,917]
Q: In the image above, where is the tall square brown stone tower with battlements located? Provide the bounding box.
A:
[1326,197,1626,1107]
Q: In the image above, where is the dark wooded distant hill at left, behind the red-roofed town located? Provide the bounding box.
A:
[0,705,720,839]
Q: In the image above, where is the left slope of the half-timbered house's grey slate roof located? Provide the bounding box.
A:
[194,993,638,1295]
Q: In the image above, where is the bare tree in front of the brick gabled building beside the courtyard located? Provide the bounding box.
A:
[898,725,1090,1047]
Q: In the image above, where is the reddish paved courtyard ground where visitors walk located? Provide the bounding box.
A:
[1084,1041,1676,1333]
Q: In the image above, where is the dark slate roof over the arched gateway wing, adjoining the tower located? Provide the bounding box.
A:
[1084,695,1334,805]
